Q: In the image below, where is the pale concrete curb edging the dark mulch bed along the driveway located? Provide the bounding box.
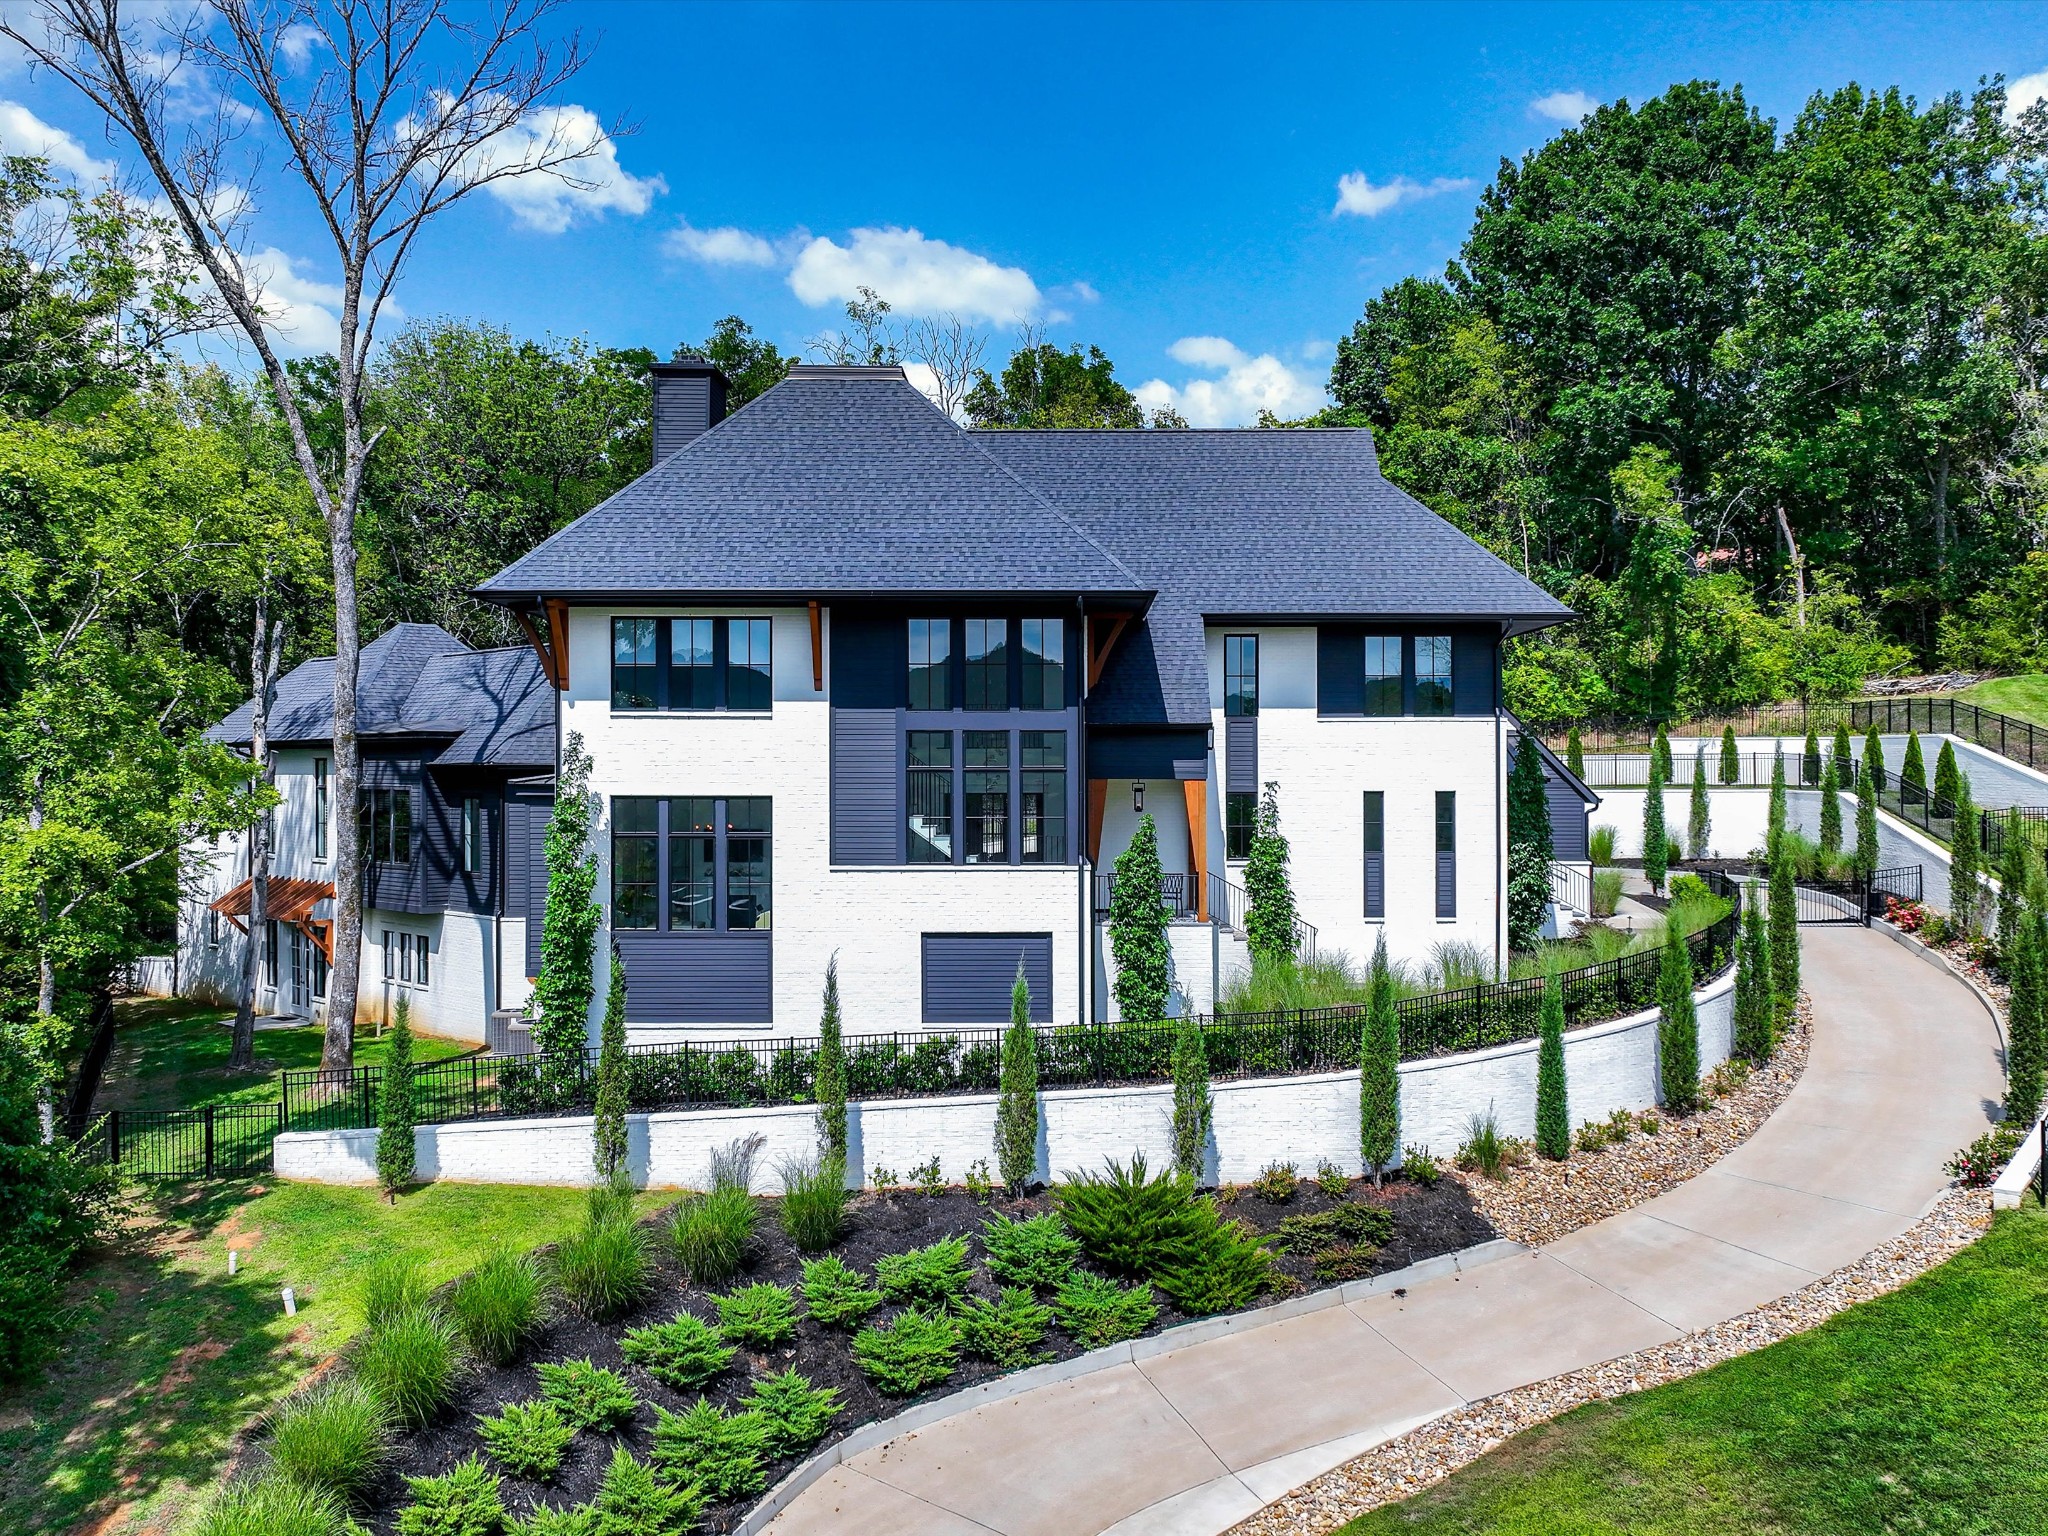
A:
[733,1237,1530,1536]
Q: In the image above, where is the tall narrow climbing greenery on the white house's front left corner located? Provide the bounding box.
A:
[532,731,602,1102]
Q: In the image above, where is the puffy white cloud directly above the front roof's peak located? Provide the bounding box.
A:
[788,225,1040,324]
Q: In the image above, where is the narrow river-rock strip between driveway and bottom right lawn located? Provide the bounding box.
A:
[1227,1190,1991,1536]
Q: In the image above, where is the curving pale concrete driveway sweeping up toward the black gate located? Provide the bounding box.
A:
[768,928,2005,1536]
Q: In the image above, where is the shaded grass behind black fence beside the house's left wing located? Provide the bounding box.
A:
[94,997,477,1110]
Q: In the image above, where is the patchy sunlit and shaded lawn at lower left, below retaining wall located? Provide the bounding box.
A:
[0,1184,666,1536]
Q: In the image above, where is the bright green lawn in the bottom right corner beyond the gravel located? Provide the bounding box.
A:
[1343,1208,2048,1536]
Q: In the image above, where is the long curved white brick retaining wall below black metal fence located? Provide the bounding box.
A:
[276,973,1735,1194]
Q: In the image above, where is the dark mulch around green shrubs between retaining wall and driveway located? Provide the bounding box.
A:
[339,1180,1495,1532]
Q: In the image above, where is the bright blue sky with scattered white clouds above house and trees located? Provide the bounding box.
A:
[0,0,2048,424]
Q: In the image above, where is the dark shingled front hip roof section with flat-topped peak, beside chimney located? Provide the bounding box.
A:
[477,367,1147,602]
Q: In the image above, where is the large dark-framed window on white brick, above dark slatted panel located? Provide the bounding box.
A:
[612,795,774,934]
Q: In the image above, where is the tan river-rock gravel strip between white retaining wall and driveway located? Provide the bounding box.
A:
[1452,993,1812,1247]
